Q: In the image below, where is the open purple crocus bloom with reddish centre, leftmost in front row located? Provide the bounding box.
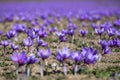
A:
[11,51,27,67]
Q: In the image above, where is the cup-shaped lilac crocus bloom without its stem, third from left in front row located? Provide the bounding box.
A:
[37,49,51,60]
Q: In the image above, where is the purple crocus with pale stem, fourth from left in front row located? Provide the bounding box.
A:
[56,48,72,75]
